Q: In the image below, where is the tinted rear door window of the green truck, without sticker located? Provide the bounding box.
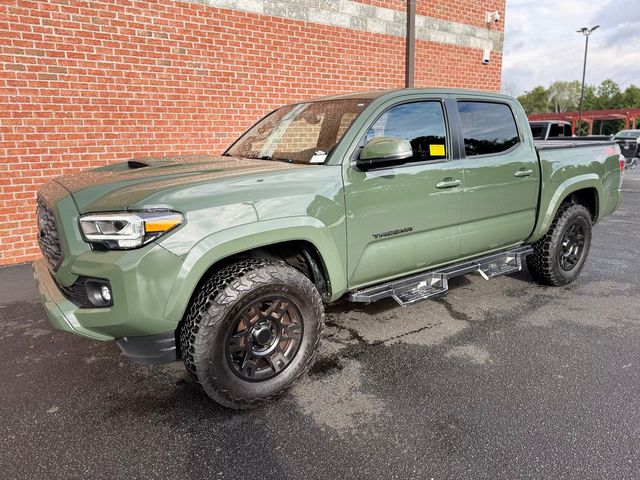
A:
[458,102,520,157]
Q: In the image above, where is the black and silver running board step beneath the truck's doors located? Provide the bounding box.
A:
[349,246,533,306]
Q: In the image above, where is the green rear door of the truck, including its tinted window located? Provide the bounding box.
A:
[456,97,540,257]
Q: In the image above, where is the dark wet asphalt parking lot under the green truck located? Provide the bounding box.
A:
[0,171,640,480]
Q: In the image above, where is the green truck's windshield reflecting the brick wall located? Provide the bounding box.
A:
[226,98,371,164]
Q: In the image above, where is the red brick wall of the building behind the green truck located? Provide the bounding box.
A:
[0,0,504,265]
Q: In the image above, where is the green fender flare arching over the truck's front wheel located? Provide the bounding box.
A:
[165,217,347,322]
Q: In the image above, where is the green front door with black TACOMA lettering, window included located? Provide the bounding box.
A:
[345,97,464,288]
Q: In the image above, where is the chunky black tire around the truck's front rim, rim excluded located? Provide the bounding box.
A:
[178,260,324,409]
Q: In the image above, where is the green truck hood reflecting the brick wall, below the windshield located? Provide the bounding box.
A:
[55,155,307,213]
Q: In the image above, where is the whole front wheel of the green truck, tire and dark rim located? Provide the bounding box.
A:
[179,260,324,408]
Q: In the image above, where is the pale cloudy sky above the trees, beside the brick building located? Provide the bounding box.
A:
[502,0,640,95]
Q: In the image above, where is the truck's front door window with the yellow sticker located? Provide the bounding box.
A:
[366,101,447,162]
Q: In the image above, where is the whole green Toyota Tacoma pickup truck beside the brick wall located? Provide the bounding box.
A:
[34,89,624,408]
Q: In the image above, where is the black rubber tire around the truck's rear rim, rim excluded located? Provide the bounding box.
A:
[527,203,591,286]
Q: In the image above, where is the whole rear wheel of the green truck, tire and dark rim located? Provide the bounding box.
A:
[527,203,591,286]
